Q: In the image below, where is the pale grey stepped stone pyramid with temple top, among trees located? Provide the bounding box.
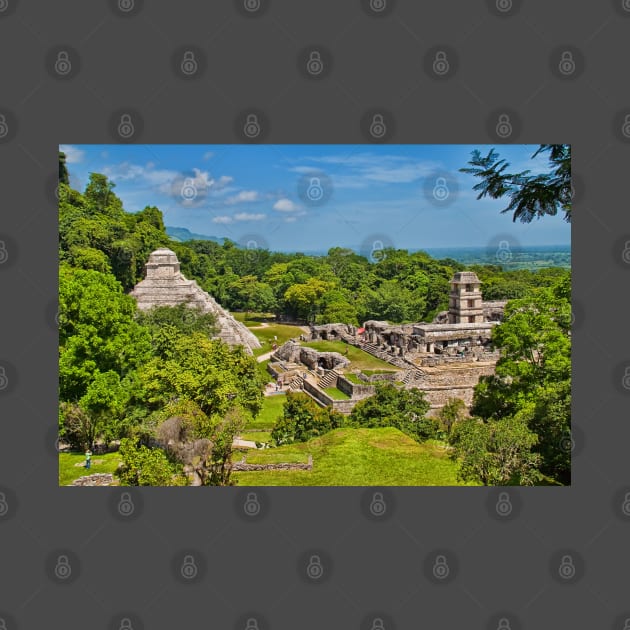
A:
[130,248,261,354]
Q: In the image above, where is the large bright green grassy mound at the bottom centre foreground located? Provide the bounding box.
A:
[233,427,472,486]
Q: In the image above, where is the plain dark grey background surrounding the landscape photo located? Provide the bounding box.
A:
[0,0,630,630]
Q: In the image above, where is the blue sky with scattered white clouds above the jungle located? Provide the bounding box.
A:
[60,144,571,251]
